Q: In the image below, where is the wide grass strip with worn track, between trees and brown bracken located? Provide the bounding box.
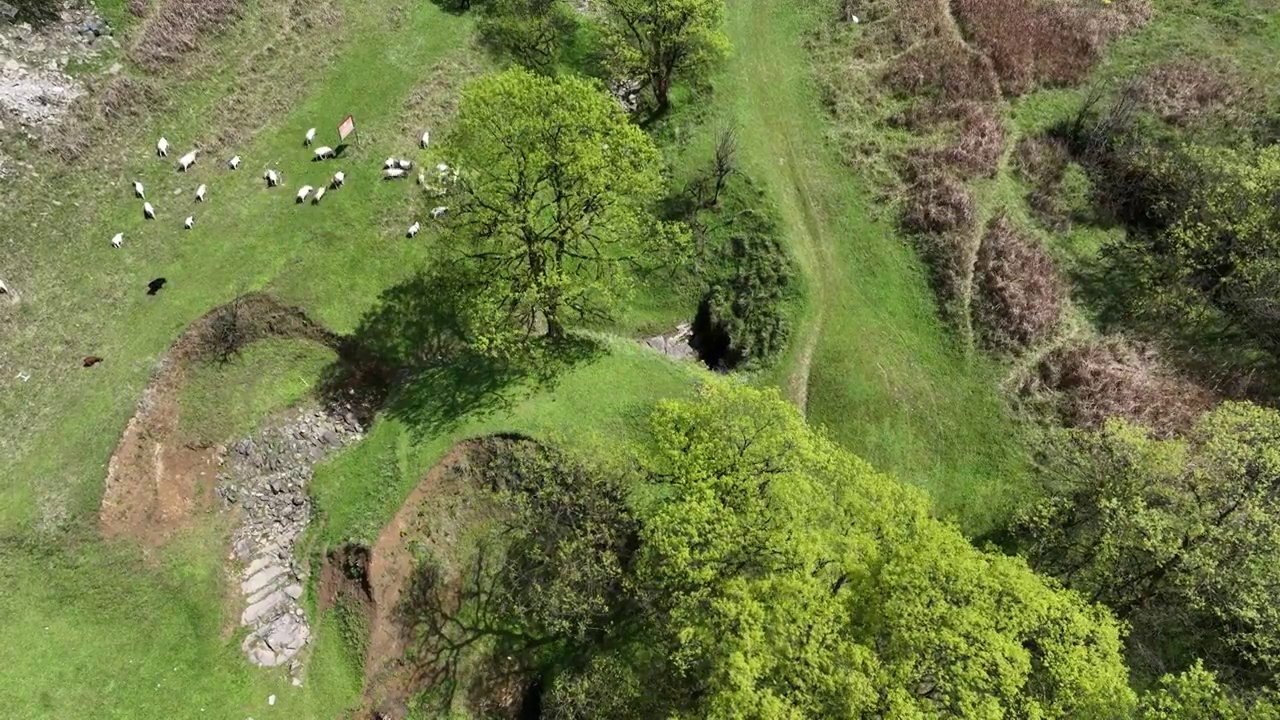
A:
[717,0,1024,532]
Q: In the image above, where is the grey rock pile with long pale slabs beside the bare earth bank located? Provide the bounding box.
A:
[218,409,362,684]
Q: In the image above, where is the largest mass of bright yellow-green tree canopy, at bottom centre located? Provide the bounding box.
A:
[547,380,1133,717]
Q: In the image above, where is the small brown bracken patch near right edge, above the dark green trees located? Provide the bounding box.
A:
[1134,60,1245,127]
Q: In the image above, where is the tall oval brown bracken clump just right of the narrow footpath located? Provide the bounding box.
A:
[973,215,1068,351]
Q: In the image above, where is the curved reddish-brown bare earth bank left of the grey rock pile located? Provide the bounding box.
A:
[99,293,337,544]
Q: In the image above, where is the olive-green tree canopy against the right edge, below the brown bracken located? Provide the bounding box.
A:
[1016,404,1280,685]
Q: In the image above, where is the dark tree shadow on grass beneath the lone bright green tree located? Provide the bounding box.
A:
[323,265,600,438]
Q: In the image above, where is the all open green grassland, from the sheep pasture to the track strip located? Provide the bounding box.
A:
[0,0,1111,720]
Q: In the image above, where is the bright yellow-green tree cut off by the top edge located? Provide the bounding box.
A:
[603,0,728,114]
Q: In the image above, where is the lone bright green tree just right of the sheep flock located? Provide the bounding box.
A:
[449,68,681,350]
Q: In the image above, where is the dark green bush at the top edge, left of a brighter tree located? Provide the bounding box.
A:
[476,0,579,74]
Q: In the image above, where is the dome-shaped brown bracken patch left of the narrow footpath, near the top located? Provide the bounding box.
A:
[884,37,1000,102]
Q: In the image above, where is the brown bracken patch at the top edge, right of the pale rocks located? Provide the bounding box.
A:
[129,0,243,72]
